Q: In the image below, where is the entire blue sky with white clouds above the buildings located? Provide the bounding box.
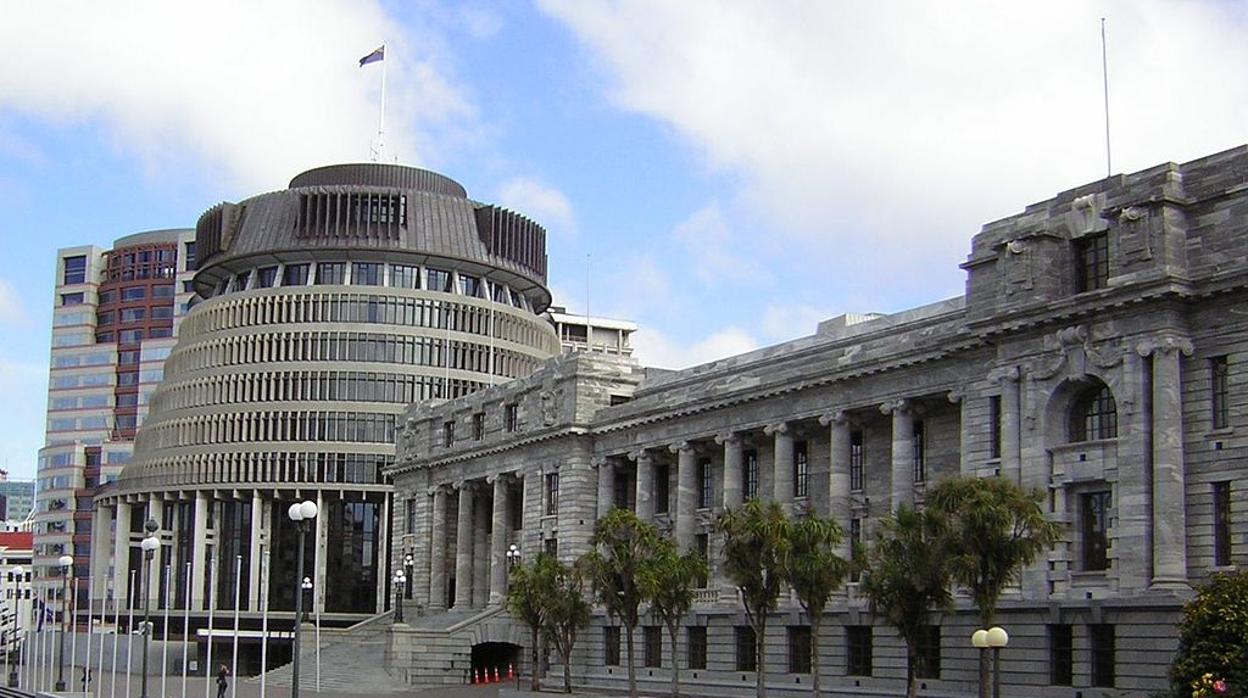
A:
[0,0,1248,474]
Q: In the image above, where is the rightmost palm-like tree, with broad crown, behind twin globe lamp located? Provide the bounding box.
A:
[926,477,1062,698]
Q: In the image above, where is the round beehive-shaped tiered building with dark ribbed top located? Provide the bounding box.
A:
[92,165,559,649]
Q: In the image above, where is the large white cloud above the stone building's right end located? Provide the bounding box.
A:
[539,0,1248,293]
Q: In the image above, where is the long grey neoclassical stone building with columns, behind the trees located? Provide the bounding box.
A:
[387,147,1248,697]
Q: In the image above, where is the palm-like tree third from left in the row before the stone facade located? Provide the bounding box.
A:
[580,508,661,698]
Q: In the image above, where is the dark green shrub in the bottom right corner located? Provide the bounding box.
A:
[1171,571,1248,698]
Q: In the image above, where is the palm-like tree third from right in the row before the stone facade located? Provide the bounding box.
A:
[784,514,849,698]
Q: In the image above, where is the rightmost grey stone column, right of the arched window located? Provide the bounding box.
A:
[1141,337,1192,588]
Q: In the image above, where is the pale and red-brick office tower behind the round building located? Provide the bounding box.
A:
[32,230,195,601]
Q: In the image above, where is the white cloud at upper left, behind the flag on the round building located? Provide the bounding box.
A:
[0,0,475,192]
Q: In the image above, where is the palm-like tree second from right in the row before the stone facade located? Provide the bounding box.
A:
[860,504,952,698]
